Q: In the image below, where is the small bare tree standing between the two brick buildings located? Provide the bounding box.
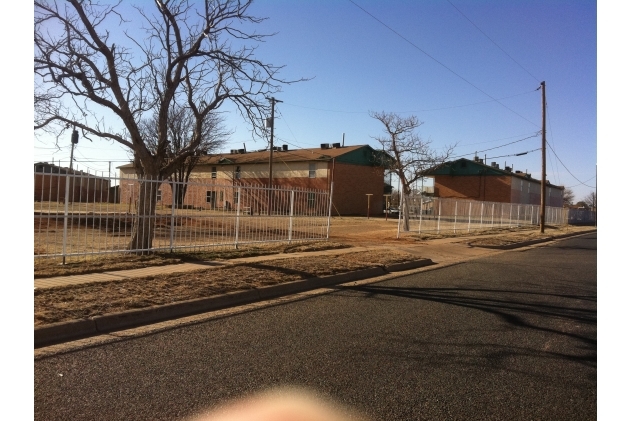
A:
[370,111,456,231]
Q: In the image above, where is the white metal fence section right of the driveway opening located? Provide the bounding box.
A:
[400,196,568,233]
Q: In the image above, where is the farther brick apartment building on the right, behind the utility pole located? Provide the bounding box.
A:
[426,158,564,207]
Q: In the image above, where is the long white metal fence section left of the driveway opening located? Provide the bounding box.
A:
[34,166,331,259]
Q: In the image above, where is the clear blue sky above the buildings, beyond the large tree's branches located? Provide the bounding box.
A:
[34,0,597,200]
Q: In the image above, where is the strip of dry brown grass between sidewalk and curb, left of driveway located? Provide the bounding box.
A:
[35,251,415,326]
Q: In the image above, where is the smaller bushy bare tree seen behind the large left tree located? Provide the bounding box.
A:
[140,104,231,207]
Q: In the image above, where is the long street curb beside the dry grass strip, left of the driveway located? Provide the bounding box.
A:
[34,259,434,348]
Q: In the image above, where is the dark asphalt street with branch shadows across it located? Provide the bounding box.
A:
[34,233,596,420]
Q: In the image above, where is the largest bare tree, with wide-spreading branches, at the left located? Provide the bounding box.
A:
[34,0,304,250]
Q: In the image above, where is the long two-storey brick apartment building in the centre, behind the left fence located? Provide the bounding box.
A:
[119,143,390,215]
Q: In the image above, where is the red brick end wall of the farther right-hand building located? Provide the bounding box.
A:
[434,175,511,203]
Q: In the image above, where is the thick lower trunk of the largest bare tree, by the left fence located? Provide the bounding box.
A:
[128,180,160,254]
